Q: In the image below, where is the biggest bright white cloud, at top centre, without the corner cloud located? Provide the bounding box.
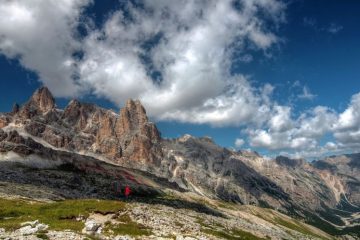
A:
[80,0,283,126]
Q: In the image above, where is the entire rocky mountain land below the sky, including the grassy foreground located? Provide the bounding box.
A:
[0,87,360,239]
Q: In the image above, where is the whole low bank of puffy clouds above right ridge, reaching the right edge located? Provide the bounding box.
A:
[246,93,360,158]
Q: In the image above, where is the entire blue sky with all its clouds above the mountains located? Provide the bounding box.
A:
[0,0,360,158]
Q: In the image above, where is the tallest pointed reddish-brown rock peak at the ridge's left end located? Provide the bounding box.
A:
[28,87,55,112]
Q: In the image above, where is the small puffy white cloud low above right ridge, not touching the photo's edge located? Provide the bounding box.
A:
[248,106,337,151]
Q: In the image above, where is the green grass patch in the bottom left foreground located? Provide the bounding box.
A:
[0,199,125,232]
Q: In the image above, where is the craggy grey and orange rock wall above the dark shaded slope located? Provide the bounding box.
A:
[0,87,360,235]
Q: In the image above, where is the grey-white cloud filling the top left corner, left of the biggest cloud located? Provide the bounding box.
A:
[0,0,89,96]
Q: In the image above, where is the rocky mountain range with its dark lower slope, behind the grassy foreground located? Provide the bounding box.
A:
[0,87,360,239]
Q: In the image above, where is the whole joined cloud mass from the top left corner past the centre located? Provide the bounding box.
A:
[0,0,285,126]
